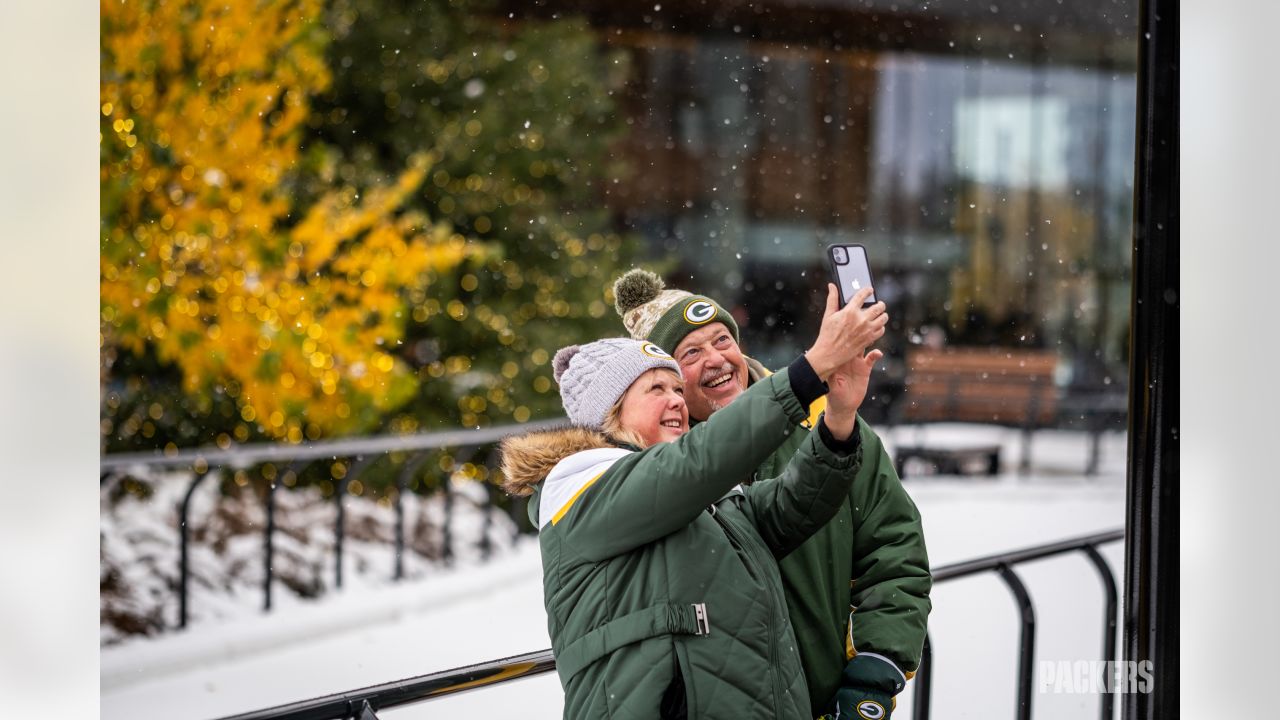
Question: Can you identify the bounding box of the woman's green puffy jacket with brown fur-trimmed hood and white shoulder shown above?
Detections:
[503,372,859,720]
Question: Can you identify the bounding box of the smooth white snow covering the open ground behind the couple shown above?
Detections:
[101,425,1125,720]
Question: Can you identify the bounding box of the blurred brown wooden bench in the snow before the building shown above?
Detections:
[893,347,1057,475]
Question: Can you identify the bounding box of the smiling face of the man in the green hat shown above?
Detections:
[672,323,746,420]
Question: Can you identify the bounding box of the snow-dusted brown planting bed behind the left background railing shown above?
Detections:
[99,469,517,646]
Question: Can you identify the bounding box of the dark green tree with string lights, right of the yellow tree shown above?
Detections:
[312,0,632,430]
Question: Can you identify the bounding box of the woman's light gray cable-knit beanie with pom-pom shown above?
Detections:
[552,337,684,429]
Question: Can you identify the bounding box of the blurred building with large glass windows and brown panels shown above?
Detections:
[504,0,1138,412]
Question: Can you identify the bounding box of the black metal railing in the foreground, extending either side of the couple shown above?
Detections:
[207,530,1124,720]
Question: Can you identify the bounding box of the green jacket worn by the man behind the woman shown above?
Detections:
[742,360,933,716]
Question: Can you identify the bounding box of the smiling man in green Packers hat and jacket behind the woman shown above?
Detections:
[613,269,932,720]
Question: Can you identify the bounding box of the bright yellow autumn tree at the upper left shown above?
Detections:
[100,0,488,447]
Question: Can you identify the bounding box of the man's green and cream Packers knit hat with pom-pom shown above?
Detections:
[613,268,739,352]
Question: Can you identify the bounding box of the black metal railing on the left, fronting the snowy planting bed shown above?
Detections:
[100,419,566,628]
